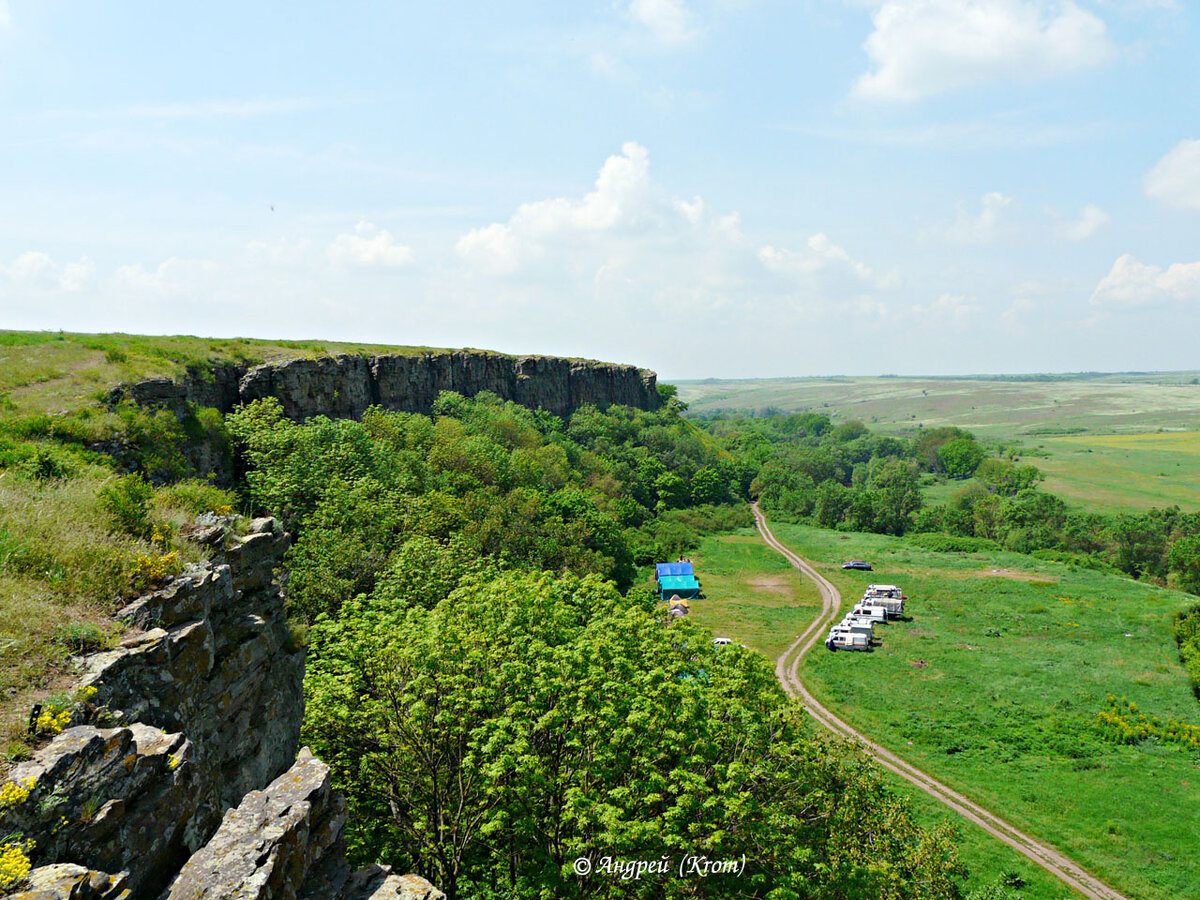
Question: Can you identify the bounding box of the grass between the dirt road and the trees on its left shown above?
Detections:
[676,528,1070,900]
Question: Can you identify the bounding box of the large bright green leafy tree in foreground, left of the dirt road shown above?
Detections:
[304,572,961,900]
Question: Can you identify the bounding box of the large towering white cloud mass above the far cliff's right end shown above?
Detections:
[453,143,896,332]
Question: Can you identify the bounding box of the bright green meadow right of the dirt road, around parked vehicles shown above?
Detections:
[774,524,1200,900]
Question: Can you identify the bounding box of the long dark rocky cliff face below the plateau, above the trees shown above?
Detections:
[113,350,659,421]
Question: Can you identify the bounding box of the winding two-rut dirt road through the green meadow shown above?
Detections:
[754,504,1128,900]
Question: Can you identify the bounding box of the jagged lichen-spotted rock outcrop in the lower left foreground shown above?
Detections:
[0,518,440,900]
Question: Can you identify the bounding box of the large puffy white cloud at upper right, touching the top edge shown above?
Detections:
[854,0,1115,101]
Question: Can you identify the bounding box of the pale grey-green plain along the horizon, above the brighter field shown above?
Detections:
[676,372,1200,440]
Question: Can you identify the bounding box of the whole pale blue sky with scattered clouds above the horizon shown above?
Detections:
[0,0,1200,378]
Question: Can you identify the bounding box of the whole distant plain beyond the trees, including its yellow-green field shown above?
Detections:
[677,372,1200,512]
